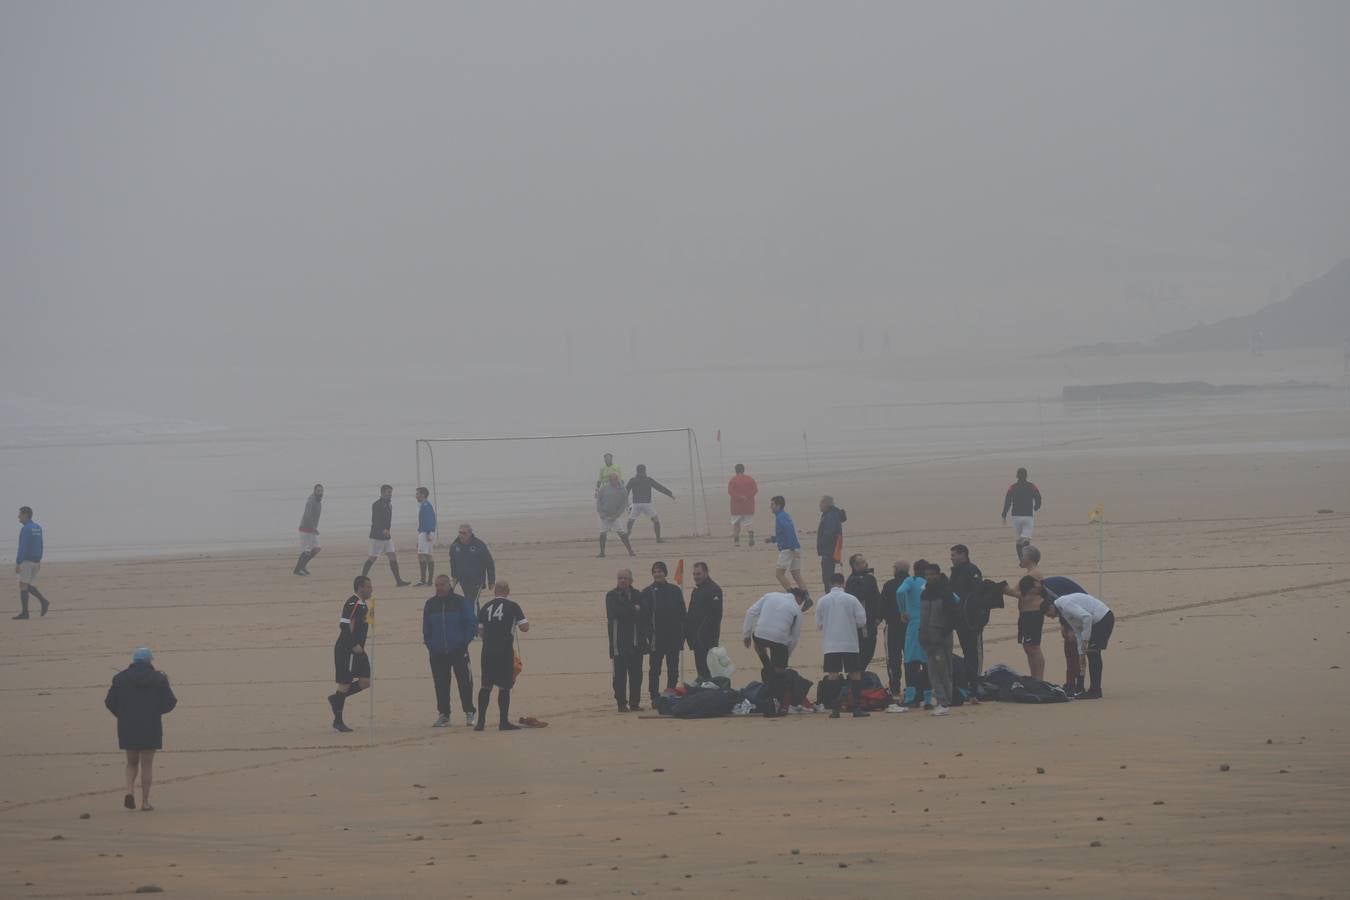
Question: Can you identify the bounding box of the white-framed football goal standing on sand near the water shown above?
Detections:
[416,428,711,541]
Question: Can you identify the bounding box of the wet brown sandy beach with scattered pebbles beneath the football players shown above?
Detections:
[0,417,1350,897]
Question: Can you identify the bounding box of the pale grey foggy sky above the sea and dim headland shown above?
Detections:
[0,0,1350,391]
